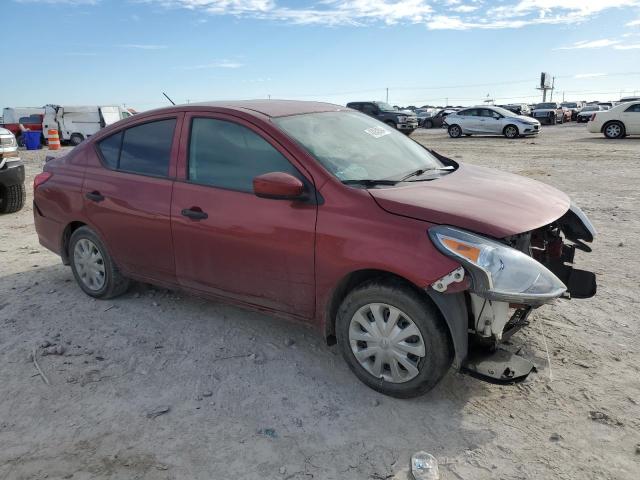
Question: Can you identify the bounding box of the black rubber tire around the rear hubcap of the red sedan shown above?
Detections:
[68,227,129,300]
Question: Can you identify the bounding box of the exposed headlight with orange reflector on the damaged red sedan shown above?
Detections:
[429,226,567,305]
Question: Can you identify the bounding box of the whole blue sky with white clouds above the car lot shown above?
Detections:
[0,0,640,110]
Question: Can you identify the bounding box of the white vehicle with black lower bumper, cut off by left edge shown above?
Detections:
[0,128,26,213]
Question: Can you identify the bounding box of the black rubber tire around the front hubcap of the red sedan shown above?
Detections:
[336,280,453,398]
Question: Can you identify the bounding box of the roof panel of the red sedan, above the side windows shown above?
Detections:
[138,99,349,117]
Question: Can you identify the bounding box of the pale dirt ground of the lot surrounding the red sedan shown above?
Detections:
[0,124,640,480]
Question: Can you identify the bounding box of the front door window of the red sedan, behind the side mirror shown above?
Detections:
[189,118,301,192]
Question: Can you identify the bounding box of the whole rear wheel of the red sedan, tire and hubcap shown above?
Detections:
[69,227,129,299]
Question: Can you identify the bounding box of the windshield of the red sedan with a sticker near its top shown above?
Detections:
[273,112,443,181]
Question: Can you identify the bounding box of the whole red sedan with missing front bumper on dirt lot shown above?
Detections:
[33,100,596,397]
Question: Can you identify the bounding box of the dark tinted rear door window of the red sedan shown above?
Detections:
[98,118,176,177]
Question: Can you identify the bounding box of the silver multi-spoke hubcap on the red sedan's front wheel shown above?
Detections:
[349,303,425,383]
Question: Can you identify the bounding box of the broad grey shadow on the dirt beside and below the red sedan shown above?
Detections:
[0,265,510,478]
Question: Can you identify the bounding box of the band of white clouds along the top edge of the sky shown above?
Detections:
[144,0,640,30]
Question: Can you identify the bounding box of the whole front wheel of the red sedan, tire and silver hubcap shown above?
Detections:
[336,281,452,398]
